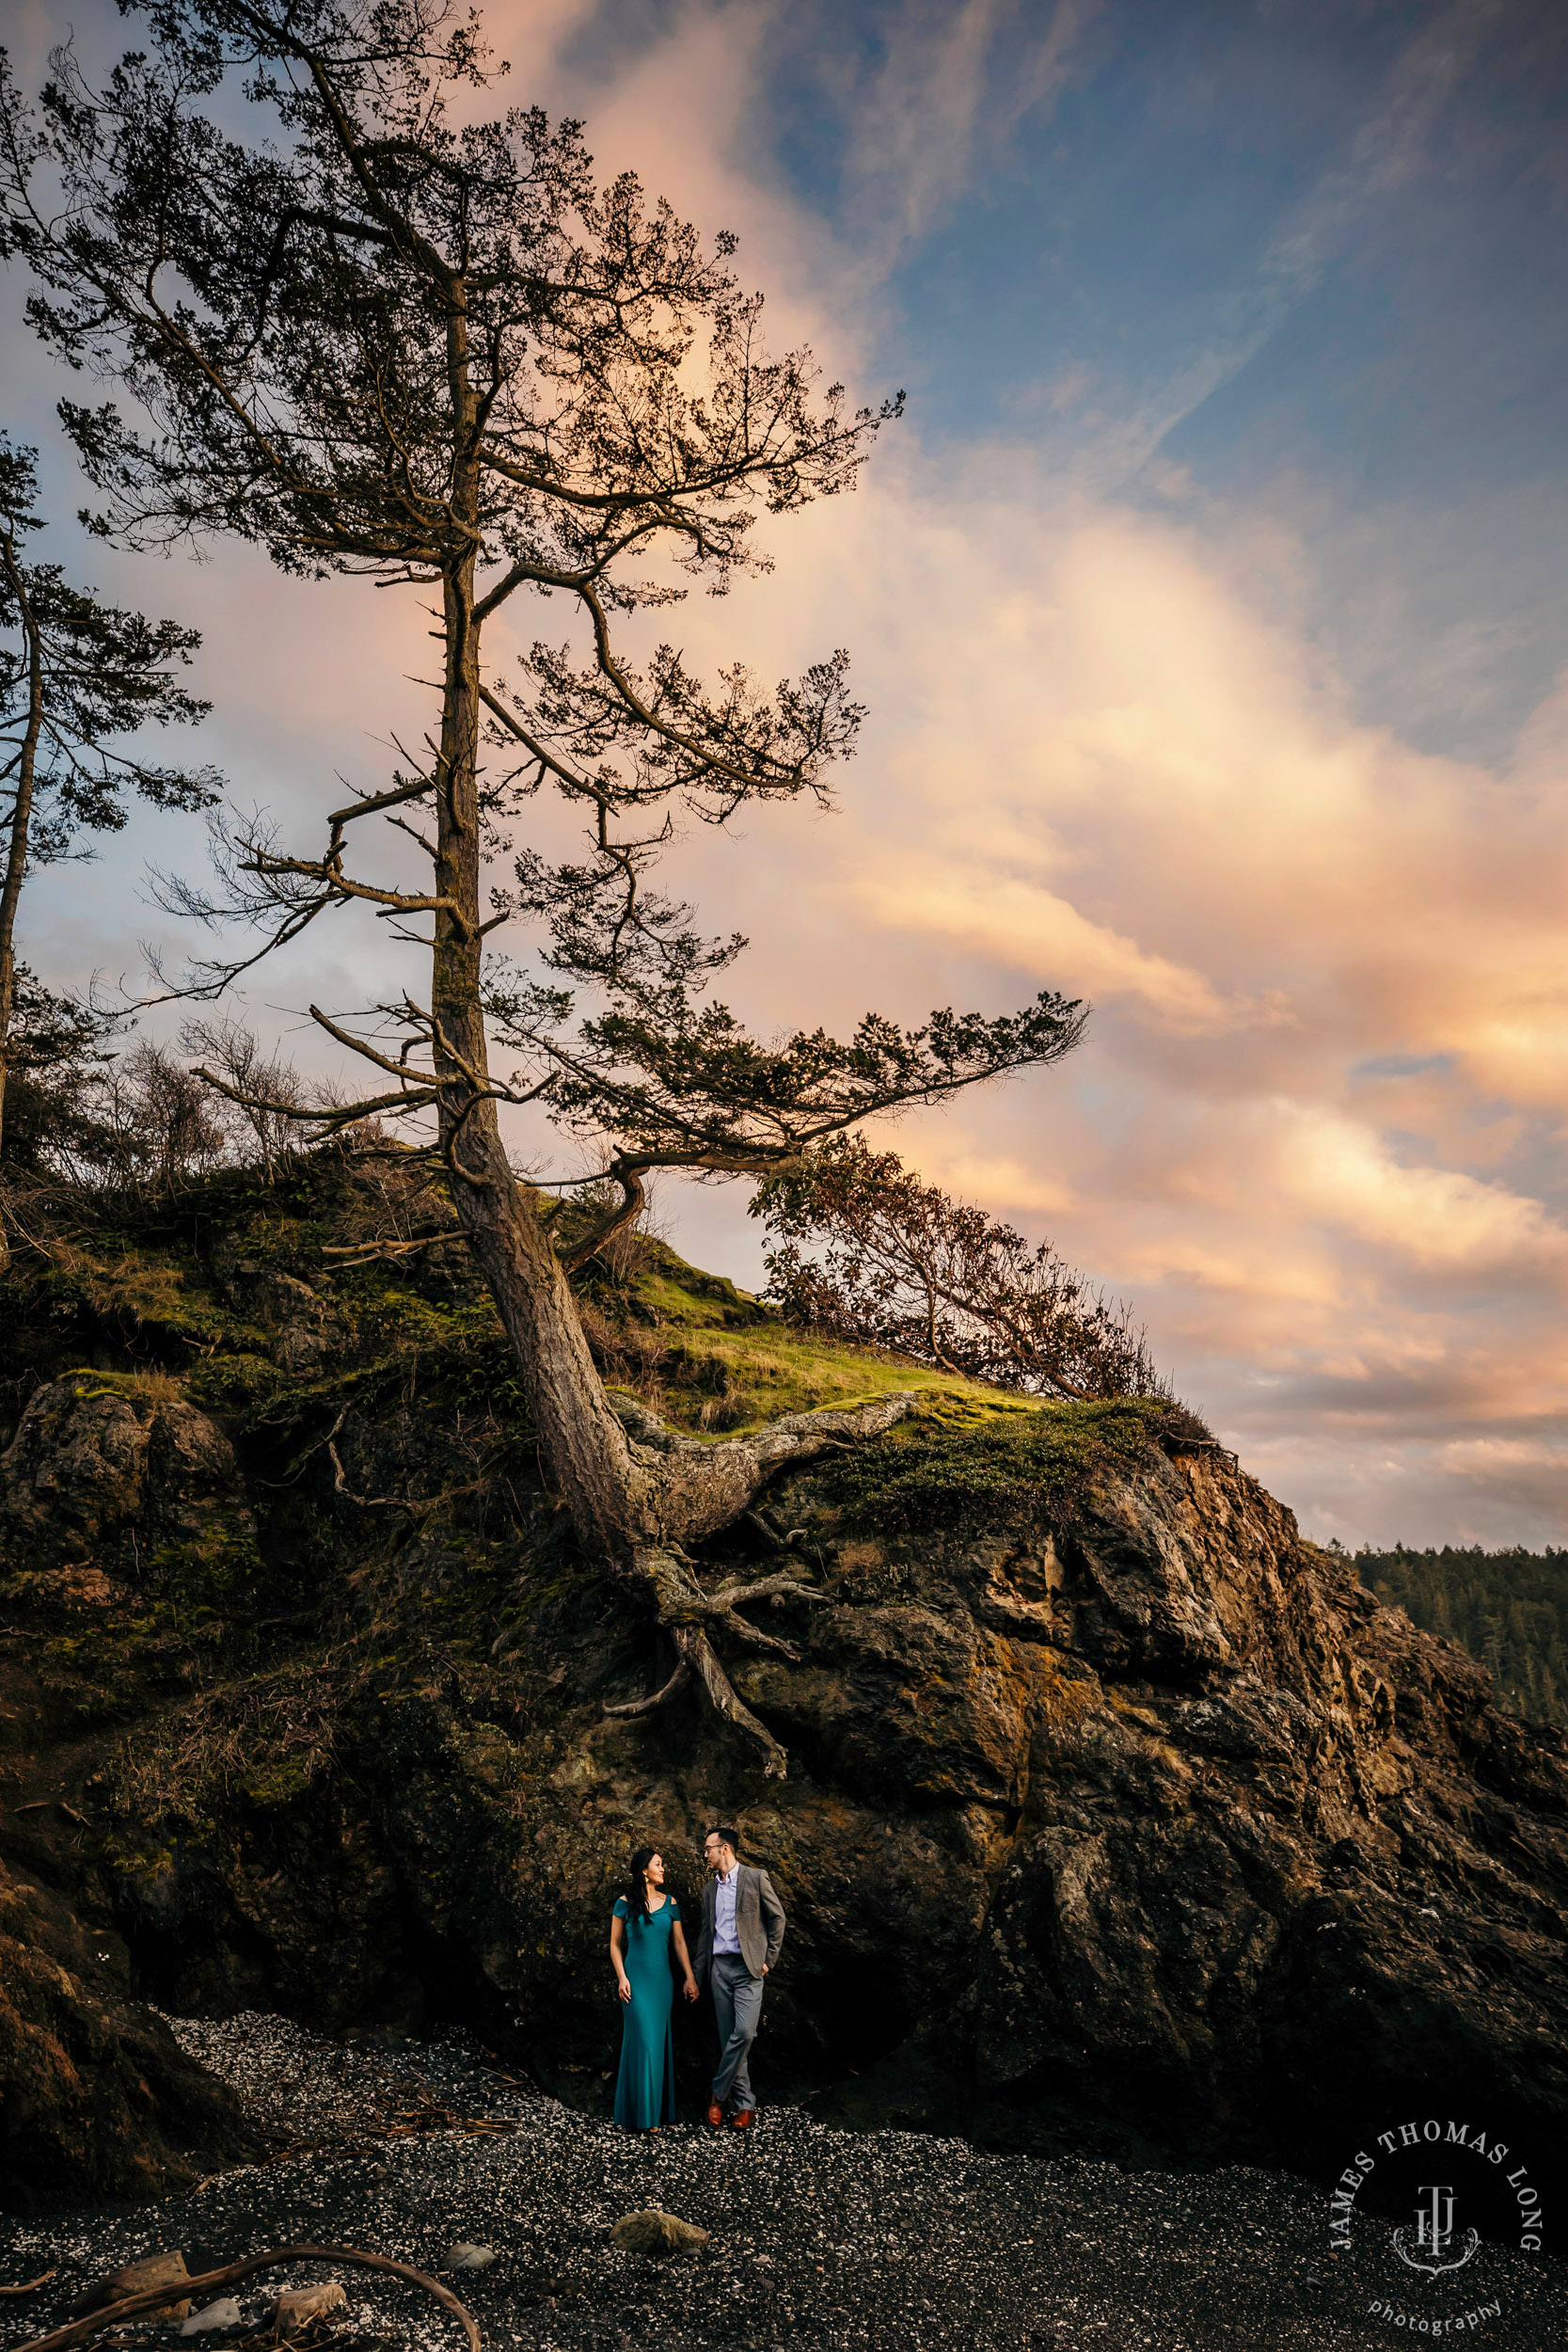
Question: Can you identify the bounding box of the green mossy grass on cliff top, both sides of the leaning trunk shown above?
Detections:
[5,1152,1162,1532]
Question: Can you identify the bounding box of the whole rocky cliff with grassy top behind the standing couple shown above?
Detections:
[0,1160,1568,2204]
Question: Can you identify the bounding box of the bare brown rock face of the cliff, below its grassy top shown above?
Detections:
[0,1223,1568,2195]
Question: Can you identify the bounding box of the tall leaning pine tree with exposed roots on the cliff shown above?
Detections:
[0,0,1082,1772]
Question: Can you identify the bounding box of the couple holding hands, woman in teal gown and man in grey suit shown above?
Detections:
[609,1828,785,2131]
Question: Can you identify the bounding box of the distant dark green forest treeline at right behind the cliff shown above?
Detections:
[1356,1543,1568,1724]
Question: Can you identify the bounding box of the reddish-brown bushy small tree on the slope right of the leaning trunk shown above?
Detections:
[752,1136,1171,1397]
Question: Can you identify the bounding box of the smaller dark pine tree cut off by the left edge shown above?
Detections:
[0,436,218,1265]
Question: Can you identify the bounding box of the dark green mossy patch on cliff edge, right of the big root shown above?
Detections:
[816,1392,1164,1536]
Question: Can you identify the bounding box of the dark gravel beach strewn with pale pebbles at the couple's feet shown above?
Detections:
[0,2016,1568,2352]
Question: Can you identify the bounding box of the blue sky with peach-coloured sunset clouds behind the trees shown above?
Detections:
[0,0,1568,1548]
